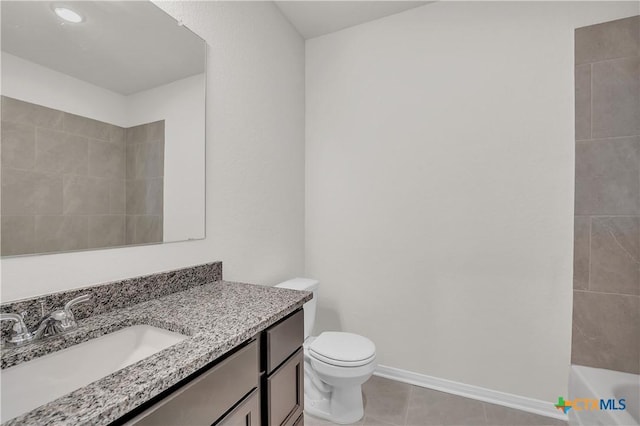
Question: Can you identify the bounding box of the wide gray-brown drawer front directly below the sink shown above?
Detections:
[126,340,259,426]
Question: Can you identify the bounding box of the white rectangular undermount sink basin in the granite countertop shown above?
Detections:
[0,325,187,423]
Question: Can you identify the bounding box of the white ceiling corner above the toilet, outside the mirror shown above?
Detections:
[275,0,431,39]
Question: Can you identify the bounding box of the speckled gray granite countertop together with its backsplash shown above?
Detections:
[1,262,312,426]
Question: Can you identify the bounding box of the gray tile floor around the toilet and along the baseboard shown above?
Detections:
[304,376,567,426]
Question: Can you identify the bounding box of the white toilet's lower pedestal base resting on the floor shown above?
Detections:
[304,386,364,425]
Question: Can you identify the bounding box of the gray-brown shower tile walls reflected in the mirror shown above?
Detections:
[1,96,164,256]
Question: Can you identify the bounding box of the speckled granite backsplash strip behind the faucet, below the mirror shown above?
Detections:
[0,262,222,338]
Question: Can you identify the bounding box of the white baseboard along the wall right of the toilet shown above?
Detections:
[373,365,567,421]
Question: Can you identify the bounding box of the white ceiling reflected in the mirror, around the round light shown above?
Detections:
[2,0,206,95]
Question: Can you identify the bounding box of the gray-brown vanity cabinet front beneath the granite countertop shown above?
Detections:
[114,309,304,426]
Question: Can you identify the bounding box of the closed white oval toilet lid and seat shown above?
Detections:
[309,331,376,367]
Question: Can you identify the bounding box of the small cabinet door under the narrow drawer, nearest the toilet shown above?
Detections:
[267,348,304,426]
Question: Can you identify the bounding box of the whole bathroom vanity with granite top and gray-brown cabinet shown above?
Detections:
[2,264,312,426]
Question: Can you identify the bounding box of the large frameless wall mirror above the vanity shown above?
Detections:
[0,1,206,256]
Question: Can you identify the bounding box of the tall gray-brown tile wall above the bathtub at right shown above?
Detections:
[571,16,640,373]
